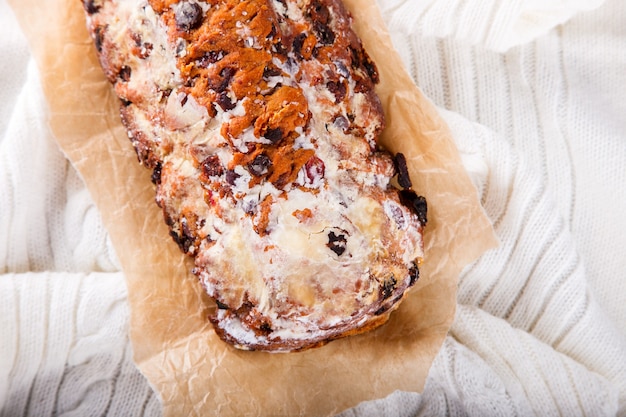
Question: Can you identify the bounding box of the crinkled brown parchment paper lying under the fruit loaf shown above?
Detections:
[9,0,496,416]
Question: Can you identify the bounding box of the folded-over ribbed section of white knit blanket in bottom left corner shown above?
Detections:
[0,272,160,417]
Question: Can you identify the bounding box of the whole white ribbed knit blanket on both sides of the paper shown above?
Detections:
[0,0,626,417]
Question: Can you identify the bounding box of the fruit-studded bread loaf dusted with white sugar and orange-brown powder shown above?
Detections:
[83,0,426,351]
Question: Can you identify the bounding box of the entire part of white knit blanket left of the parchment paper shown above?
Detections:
[0,1,161,417]
